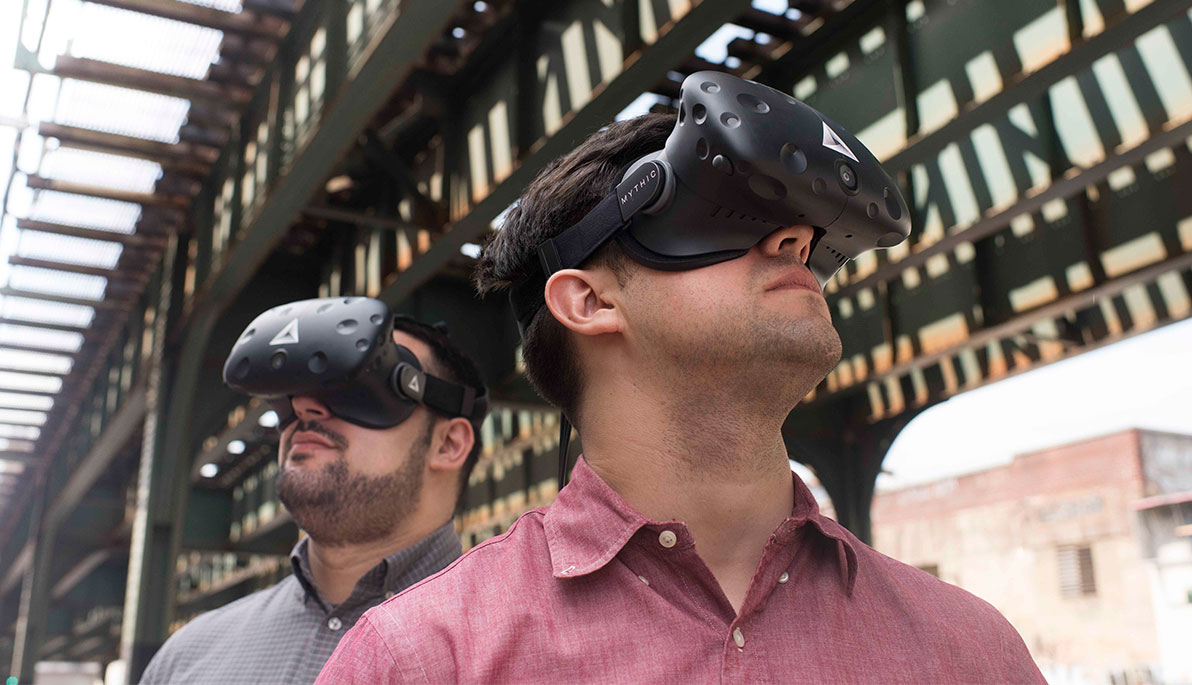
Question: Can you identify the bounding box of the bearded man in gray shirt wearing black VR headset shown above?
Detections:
[142,312,486,683]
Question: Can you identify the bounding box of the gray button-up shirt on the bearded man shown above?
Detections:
[141,523,460,683]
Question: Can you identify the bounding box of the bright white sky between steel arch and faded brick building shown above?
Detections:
[877,320,1192,490]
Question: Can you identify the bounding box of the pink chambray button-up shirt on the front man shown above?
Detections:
[318,459,1044,684]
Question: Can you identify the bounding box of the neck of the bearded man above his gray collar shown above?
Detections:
[306,522,443,604]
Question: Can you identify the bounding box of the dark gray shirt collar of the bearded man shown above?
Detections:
[290,521,461,603]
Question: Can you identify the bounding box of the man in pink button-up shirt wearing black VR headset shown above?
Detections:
[319,73,1043,684]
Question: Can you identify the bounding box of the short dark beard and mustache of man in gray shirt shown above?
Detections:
[278,417,434,547]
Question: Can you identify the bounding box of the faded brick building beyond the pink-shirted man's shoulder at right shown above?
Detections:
[873,430,1192,683]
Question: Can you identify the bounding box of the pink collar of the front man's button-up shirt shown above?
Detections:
[542,456,857,594]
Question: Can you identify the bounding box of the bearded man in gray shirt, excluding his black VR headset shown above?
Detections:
[141,317,484,683]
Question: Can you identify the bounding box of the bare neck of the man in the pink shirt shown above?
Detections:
[581,362,794,610]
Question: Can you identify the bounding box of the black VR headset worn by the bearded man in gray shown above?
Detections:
[223,298,489,429]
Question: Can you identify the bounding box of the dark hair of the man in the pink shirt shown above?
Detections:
[474,114,675,422]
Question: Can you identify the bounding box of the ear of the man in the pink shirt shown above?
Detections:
[544,269,623,336]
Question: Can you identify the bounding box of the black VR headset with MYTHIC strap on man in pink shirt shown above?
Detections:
[509,71,911,487]
